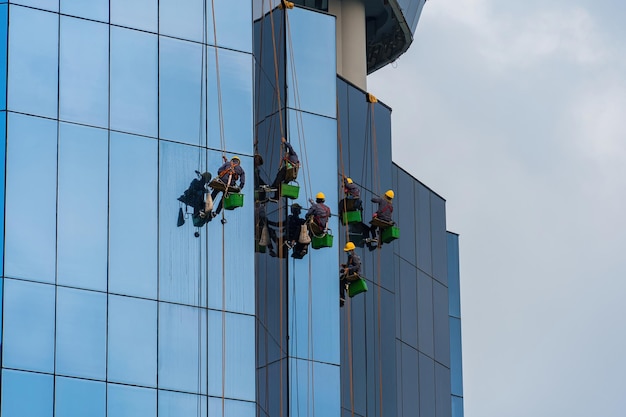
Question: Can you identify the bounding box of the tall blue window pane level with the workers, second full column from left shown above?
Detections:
[57,123,108,291]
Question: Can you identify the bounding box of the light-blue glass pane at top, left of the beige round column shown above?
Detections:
[286,8,337,117]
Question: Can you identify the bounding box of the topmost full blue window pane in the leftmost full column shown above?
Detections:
[8,6,59,118]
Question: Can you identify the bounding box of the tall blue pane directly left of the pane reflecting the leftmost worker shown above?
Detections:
[109,132,158,299]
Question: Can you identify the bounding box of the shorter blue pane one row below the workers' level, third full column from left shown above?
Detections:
[108,295,157,387]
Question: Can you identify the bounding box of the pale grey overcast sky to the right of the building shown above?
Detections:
[368,0,626,417]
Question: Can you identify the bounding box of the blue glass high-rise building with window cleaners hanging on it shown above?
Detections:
[0,0,463,417]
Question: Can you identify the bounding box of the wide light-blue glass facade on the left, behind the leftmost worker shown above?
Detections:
[0,0,256,417]
